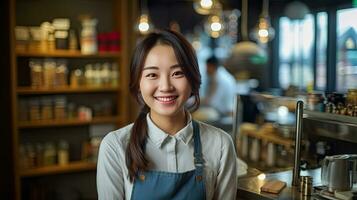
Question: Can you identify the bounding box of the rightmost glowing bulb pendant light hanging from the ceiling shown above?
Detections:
[251,0,275,44]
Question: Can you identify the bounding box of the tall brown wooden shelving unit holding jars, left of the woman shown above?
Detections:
[9,0,137,200]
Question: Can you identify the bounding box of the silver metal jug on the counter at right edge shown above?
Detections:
[321,154,357,192]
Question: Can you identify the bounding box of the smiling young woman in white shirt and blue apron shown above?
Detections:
[97,30,237,200]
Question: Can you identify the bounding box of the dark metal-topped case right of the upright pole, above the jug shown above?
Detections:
[303,109,357,168]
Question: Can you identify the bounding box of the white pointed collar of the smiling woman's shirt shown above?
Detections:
[146,112,193,148]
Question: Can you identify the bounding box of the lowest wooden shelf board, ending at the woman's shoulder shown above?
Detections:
[20,161,97,178]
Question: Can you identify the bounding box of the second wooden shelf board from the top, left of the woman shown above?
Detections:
[16,86,119,95]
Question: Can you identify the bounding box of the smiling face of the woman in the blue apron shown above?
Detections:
[140,45,192,118]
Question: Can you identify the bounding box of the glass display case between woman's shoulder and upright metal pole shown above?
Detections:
[233,93,305,172]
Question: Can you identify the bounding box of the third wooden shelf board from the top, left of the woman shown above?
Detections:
[18,116,120,128]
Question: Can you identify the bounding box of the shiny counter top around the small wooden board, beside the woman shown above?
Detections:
[237,168,321,200]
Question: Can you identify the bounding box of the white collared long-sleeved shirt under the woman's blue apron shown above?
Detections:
[97,115,237,200]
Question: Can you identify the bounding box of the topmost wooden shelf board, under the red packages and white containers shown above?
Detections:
[16,50,121,58]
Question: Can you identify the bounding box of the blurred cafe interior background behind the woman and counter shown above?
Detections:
[0,0,357,199]
